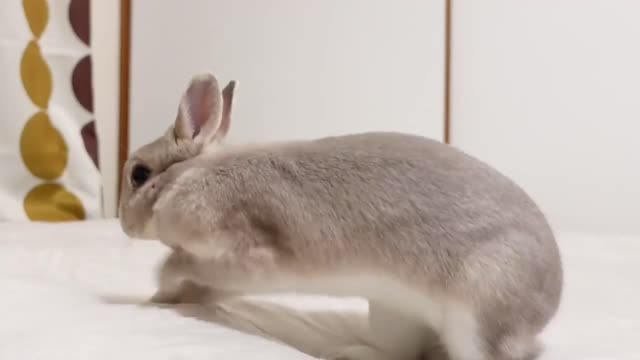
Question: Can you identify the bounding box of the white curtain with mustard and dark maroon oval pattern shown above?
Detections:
[0,0,102,221]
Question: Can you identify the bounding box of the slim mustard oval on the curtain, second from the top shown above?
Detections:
[20,40,53,110]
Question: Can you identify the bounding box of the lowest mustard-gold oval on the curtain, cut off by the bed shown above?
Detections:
[23,183,85,222]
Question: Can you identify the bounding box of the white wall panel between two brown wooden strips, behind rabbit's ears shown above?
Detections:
[130,0,444,149]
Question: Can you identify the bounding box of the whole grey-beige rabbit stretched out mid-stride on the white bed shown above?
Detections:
[119,72,563,360]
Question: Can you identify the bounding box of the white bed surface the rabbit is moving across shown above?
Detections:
[0,220,640,360]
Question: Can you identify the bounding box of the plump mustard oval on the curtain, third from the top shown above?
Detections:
[20,112,69,180]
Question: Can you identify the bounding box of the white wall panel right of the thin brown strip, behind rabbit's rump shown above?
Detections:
[452,0,640,234]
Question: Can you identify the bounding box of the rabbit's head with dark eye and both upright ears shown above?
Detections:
[119,73,236,239]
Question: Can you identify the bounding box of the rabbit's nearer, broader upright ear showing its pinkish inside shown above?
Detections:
[174,73,228,144]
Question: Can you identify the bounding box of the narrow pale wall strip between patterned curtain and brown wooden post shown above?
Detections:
[91,0,120,217]
